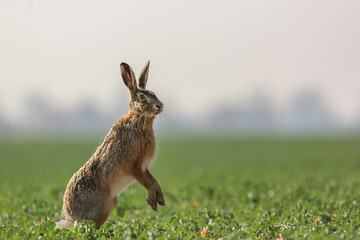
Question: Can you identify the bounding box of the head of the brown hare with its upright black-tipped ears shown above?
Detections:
[120,61,164,117]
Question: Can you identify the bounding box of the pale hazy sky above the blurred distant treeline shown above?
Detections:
[0,0,360,125]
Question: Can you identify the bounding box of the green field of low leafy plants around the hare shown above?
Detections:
[0,138,360,239]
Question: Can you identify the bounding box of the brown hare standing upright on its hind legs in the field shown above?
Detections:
[56,61,165,229]
